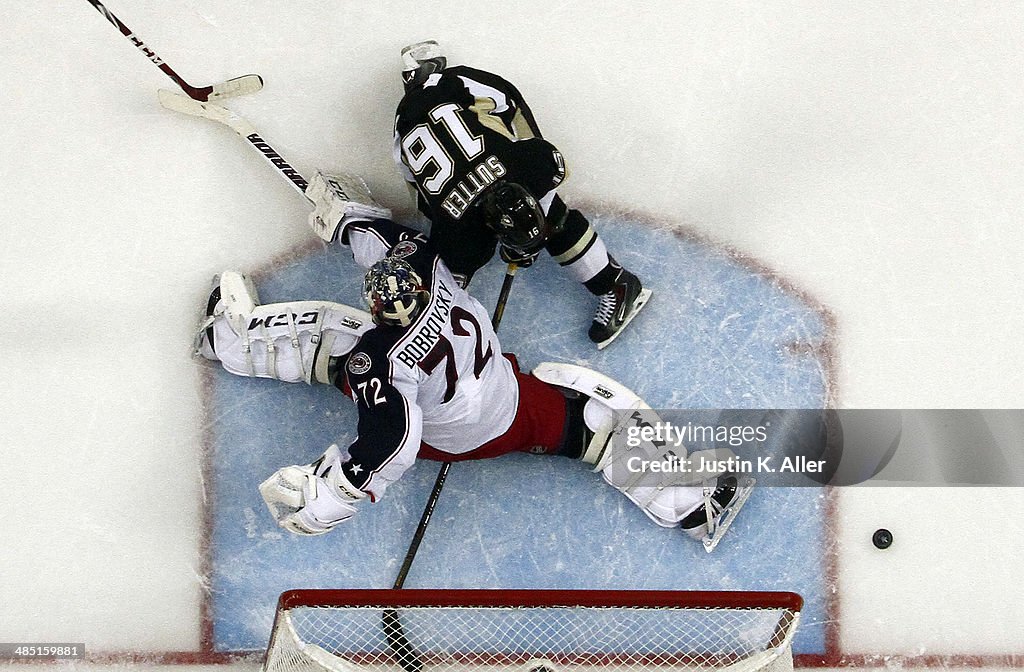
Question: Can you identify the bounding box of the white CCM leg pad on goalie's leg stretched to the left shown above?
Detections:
[203,301,374,384]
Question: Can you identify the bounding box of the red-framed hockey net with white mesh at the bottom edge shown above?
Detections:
[264,590,803,672]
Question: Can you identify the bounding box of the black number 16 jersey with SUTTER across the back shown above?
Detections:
[394,66,565,274]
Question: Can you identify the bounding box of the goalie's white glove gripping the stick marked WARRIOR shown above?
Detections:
[306,170,391,243]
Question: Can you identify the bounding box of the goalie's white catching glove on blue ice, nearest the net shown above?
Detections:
[259,444,367,536]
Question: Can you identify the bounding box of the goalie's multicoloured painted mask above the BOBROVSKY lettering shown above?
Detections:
[362,257,430,327]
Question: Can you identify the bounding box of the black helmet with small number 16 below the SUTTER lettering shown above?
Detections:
[481,180,548,253]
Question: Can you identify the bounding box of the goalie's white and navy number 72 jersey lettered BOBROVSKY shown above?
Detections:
[336,225,519,499]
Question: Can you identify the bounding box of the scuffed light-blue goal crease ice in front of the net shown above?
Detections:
[210,217,828,653]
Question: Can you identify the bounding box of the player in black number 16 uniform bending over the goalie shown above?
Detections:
[394,41,650,348]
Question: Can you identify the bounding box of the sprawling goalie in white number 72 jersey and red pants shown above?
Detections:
[196,174,752,550]
